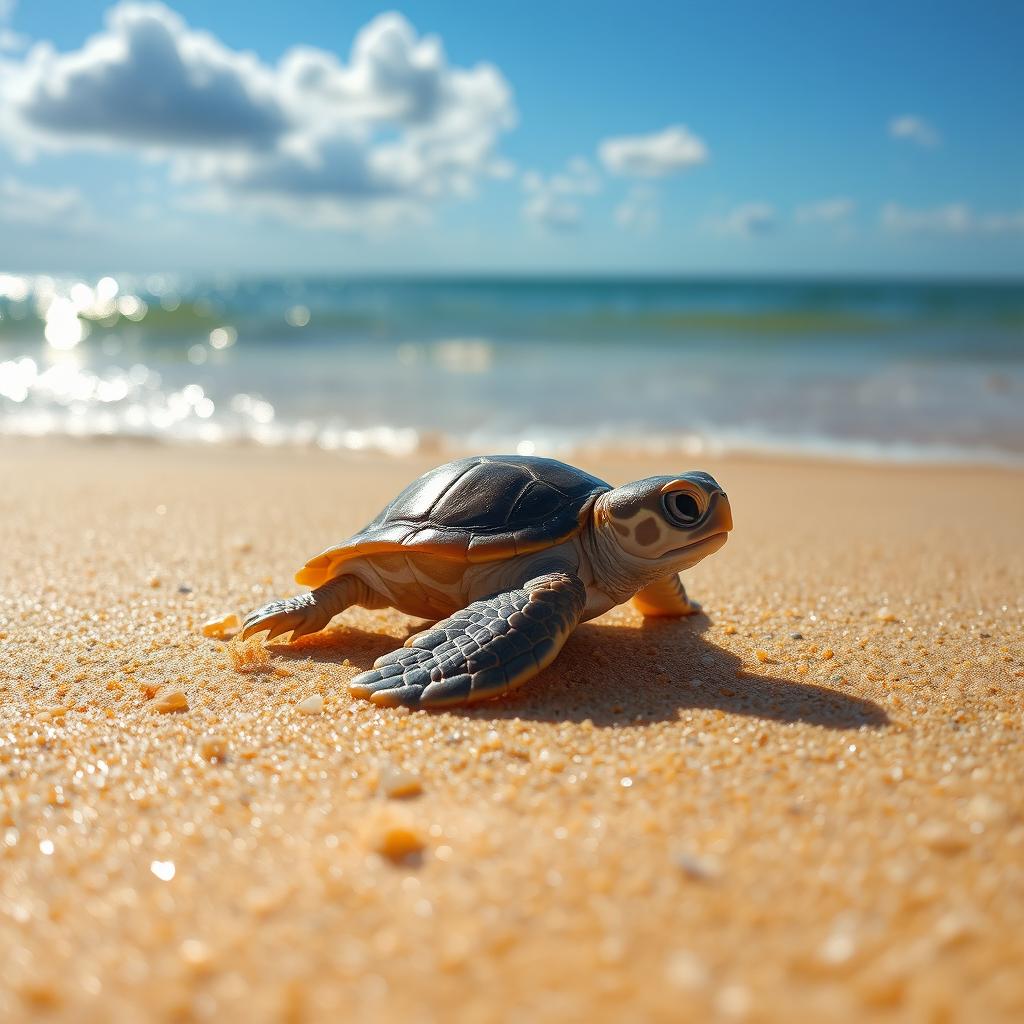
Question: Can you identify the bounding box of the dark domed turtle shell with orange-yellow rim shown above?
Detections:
[295,456,611,587]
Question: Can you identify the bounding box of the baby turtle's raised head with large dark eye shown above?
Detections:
[596,472,732,571]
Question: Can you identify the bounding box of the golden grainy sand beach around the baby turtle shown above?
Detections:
[0,441,1024,1022]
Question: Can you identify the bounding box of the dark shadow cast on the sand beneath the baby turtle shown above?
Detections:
[272,614,889,729]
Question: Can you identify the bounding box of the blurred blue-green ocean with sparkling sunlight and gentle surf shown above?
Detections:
[0,273,1024,463]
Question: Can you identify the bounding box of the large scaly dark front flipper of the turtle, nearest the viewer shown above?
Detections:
[349,572,587,708]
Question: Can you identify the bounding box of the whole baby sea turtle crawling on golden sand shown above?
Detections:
[242,456,732,708]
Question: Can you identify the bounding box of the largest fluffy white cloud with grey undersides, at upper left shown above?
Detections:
[0,0,515,226]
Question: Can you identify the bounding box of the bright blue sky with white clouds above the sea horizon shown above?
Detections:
[0,0,1024,275]
